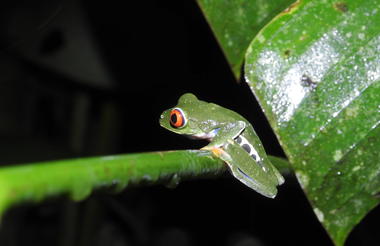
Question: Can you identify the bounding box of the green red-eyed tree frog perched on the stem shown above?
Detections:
[160,93,284,198]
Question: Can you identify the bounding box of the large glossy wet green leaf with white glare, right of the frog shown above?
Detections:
[245,0,380,245]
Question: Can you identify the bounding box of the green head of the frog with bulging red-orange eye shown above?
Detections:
[160,93,205,137]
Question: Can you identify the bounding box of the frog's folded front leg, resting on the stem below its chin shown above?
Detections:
[202,121,246,150]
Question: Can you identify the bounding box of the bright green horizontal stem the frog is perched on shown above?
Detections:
[0,150,288,219]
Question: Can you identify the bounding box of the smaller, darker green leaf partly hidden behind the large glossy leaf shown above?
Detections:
[198,0,294,78]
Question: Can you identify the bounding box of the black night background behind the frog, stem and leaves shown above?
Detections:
[0,0,379,246]
